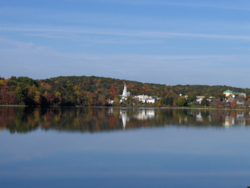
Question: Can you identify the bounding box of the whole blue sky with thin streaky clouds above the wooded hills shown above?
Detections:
[0,0,250,88]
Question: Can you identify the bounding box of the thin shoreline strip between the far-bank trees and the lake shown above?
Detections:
[0,104,250,111]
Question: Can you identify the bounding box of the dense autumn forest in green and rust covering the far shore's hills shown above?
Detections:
[0,76,250,106]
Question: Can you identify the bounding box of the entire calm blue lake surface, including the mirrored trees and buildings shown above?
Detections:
[0,107,250,188]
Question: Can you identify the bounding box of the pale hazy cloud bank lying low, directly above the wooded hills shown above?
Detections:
[0,38,250,87]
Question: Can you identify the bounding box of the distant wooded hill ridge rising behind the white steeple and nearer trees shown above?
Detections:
[40,76,250,97]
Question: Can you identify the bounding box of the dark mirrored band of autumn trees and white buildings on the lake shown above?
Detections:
[0,107,250,133]
